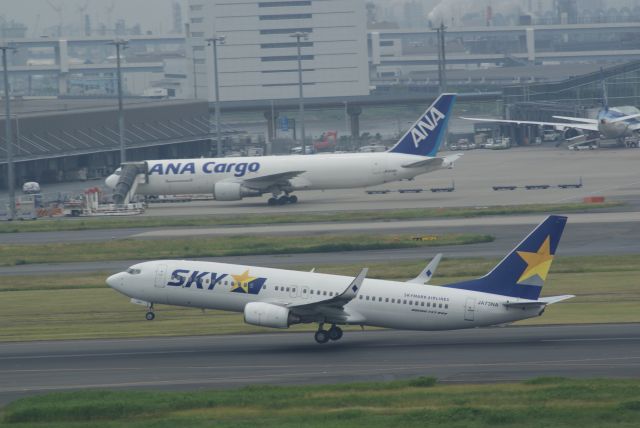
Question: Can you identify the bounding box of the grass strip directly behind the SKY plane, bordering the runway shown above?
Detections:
[0,255,640,342]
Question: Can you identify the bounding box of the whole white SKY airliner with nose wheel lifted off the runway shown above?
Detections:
[107,215,574,343]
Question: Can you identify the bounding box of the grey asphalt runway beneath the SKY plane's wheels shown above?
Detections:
[0,324,640,404]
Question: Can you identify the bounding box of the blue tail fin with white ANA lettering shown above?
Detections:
[389,94,456,157]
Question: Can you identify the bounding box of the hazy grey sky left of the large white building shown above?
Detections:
[0,0,182,36]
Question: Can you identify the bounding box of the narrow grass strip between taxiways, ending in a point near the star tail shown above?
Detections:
[0,234,493,266]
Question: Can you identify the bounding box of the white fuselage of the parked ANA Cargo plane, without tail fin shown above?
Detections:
[127,152,442,195]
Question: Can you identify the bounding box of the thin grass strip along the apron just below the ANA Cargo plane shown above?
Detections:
[0,202,623,233]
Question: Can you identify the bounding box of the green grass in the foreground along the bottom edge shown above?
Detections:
[0,378,640,428]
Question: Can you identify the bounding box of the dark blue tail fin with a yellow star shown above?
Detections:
[445,215,567,300]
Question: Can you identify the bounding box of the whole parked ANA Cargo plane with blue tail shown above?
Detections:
[106,94,461,205]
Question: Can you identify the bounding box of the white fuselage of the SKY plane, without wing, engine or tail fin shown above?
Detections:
[108,260,541,330]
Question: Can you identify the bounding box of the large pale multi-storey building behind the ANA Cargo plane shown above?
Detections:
[187,0,369,101]
